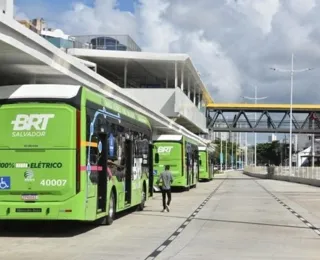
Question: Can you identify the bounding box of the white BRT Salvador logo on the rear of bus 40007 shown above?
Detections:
[11,114,55,137]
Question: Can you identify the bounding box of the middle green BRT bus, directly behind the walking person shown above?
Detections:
[153,135,199,190]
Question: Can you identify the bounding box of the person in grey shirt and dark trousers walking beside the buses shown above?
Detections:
[157,165,173,212]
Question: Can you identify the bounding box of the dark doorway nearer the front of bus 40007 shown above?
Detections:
[125,139,133,204]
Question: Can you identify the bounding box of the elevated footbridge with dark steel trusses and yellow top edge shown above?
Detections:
[206,103,320,134]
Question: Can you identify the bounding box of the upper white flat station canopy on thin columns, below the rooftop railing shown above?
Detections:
[67,36,213,104]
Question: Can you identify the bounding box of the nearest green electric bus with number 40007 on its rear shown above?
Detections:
[0,85,153,225]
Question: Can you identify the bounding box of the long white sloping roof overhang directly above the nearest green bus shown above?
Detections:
[0,13,209,146]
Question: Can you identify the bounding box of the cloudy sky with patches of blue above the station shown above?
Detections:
[15,0,320,144]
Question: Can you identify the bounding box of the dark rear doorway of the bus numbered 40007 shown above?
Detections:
[97,133,108,212]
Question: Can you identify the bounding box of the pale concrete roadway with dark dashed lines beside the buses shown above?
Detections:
[0,172,320,260]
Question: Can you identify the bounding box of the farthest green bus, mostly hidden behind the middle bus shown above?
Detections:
[199,146,214,181]
